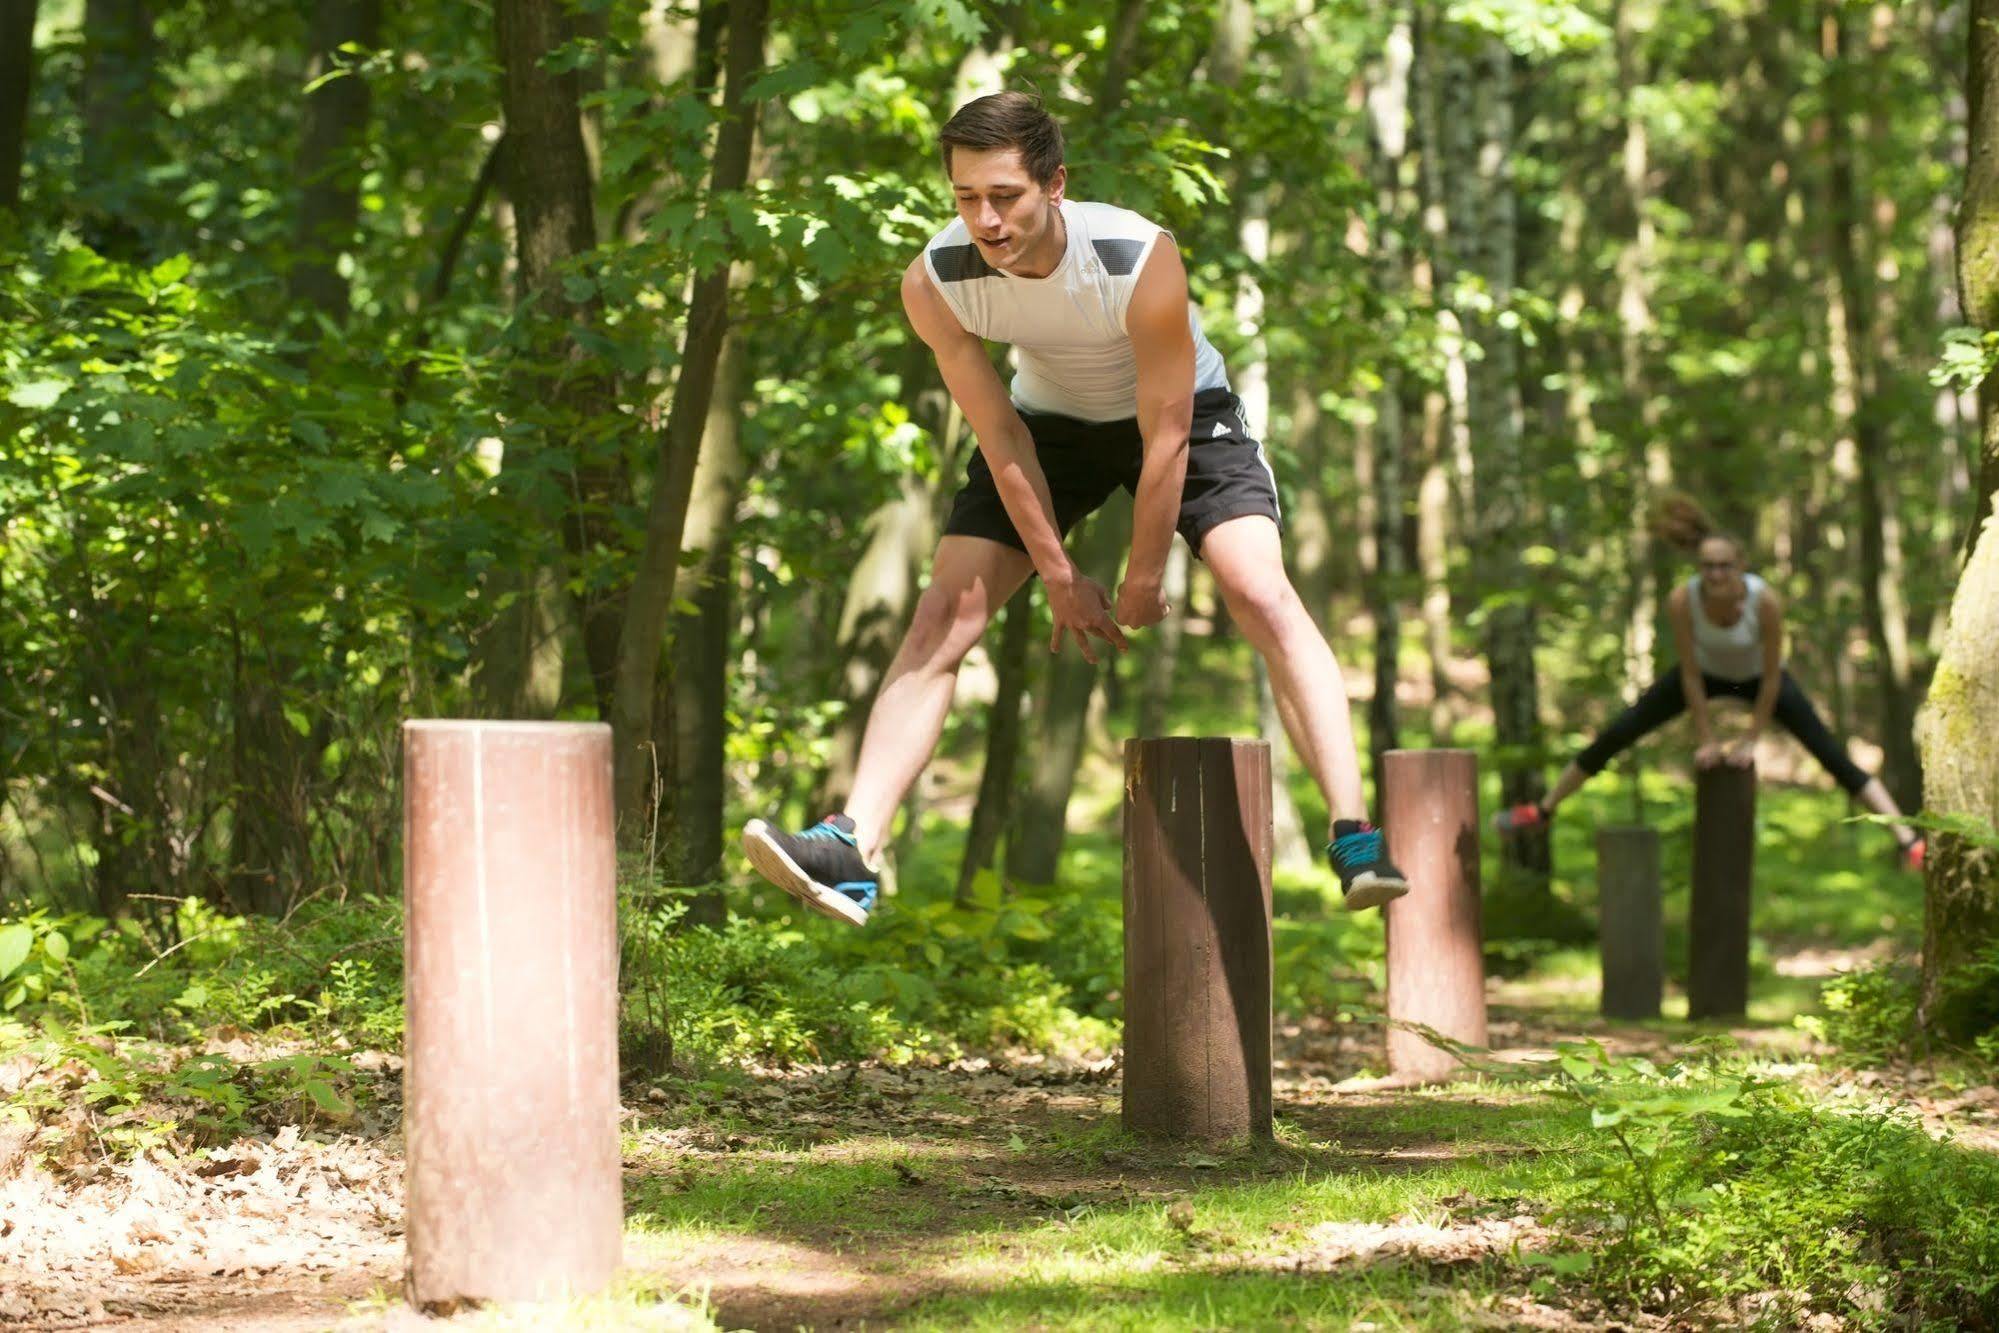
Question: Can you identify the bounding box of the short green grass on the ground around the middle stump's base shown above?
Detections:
[628,1087,1583,1329]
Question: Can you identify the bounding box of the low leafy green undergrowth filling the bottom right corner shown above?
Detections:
[1551,1043,1999,1327]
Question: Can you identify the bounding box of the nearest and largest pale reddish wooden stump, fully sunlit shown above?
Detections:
[402,721,624,1309]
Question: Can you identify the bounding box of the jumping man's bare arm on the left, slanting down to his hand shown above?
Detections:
[902,256,1125,662]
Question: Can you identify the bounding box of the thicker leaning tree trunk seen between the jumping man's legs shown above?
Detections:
[1005,492,1157,883]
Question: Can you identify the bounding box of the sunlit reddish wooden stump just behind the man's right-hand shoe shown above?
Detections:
[1381,749,1485,1083]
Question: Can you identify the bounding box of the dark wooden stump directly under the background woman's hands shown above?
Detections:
[1687,763,1755,1019]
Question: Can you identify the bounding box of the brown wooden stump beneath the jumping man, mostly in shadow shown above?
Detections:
[1123,737,1271,1141]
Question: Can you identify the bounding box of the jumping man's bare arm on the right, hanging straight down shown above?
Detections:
[1117,234,1193,626]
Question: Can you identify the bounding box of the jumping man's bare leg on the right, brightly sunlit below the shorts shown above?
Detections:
[1201,514,1367,837]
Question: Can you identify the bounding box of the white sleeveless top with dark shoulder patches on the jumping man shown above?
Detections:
[924,200,1229,422]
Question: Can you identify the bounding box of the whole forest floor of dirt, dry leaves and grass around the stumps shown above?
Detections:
[0,949,1999,1329]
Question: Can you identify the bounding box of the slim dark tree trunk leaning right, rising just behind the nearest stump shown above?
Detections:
[612,0,770,837]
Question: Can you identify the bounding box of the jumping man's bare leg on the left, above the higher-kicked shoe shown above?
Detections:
[846,536,1033,863]
